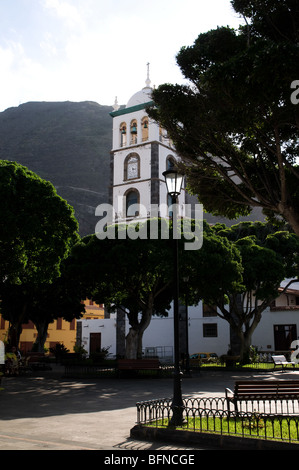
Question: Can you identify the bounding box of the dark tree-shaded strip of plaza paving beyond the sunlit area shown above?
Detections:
[0,371,295,420]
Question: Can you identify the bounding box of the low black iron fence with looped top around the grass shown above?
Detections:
[136,397,299,444]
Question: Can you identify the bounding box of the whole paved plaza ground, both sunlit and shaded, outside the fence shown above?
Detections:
[0,366,299,451]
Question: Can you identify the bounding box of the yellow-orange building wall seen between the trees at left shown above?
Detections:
[0,299,104,353]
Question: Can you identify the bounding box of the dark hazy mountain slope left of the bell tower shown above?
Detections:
[0,102,112,236]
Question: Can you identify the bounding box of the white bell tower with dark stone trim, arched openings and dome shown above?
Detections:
[110,64,185,222]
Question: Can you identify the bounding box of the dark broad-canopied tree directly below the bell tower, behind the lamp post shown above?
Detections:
[69,220,241,358]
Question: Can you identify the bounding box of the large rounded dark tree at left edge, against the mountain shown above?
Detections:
[0,160,79,342]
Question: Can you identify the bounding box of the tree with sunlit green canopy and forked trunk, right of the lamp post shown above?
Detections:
[192,222,299,362]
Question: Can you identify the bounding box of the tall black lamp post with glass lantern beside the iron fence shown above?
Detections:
[163,168,184,426]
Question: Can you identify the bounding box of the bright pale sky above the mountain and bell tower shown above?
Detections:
[0,0,242,111]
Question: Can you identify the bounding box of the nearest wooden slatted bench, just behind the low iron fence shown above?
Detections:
[225,380,299,412]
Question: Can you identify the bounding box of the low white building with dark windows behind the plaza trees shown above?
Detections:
[77,288,299,362]
